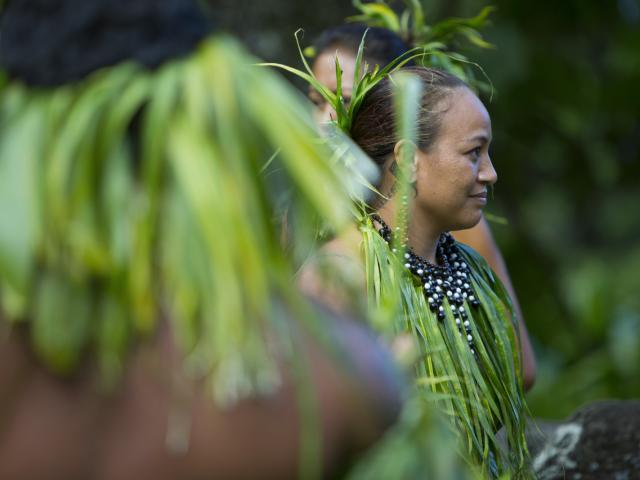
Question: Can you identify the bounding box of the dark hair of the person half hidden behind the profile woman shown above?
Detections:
[313,23,410,67]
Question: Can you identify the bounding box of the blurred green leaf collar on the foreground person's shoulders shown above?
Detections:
[0,38,360,402]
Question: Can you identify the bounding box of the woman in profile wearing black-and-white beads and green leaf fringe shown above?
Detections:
[302,67,527,478]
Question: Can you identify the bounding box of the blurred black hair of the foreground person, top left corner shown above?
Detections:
[0,0,212,86]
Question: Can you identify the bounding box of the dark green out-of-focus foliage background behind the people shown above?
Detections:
[212,0,640,418]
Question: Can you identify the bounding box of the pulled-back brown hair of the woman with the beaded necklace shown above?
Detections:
[351,67,468,168]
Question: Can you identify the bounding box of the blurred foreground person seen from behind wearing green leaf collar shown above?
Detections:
[0,0,402,479]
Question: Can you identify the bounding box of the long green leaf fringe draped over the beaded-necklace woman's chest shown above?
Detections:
[360,217,529,478]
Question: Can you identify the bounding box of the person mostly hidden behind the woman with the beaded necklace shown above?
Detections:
[309,24,536,390]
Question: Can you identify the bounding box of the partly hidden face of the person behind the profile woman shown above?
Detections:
[308,49,356,123]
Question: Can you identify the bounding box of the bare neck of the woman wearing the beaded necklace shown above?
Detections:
[377,197,442,264]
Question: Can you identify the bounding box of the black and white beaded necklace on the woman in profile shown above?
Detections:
[371,214,480,355]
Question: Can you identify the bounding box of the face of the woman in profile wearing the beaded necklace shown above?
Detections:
[414,88,498,231]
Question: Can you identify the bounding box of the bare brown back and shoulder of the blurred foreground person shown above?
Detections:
[0,308,402,480]
